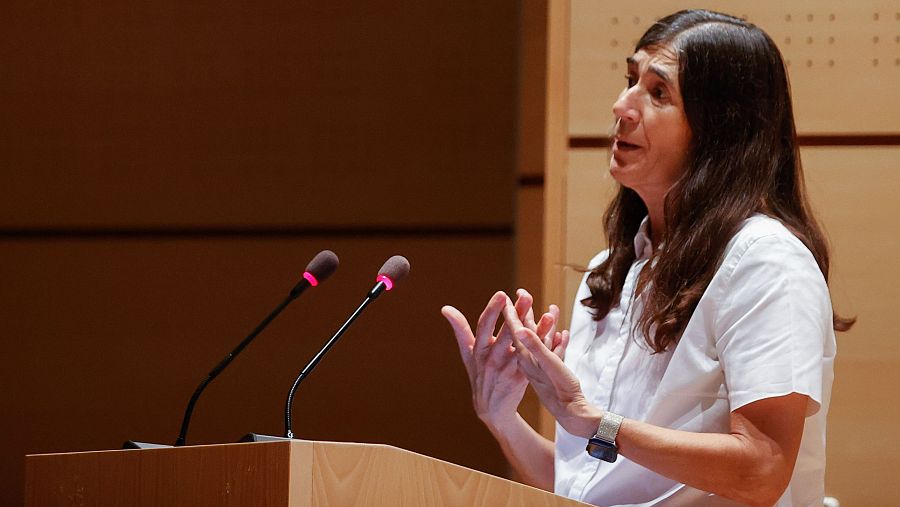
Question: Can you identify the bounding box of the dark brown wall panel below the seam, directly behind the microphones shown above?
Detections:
[0,236,513,505]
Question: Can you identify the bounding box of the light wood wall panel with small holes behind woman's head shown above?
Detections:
[569,0,900,136]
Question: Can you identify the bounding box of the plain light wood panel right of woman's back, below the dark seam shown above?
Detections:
[803,147,900,505]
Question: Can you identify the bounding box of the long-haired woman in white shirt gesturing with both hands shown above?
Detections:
[442,10,852,505]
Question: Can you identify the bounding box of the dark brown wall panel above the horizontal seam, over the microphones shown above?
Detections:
[0,1,517,228]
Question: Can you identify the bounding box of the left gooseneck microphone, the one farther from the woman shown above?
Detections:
[175,250,339,446]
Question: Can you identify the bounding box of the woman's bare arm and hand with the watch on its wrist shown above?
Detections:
[504,307,808,505]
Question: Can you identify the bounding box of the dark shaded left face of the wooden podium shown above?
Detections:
[25,442,291,507]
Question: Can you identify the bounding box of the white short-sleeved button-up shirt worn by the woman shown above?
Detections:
[555,215,835,506]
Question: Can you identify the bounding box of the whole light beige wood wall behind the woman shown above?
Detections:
[519,0,900,505]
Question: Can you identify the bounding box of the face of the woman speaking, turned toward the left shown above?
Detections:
[609,46,691,200]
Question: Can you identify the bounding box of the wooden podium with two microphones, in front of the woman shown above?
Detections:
[25,440,586,507]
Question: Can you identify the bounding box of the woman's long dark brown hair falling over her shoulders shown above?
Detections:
[582,10,854,352]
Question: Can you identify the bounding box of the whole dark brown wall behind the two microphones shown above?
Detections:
[0,2,518,505]
